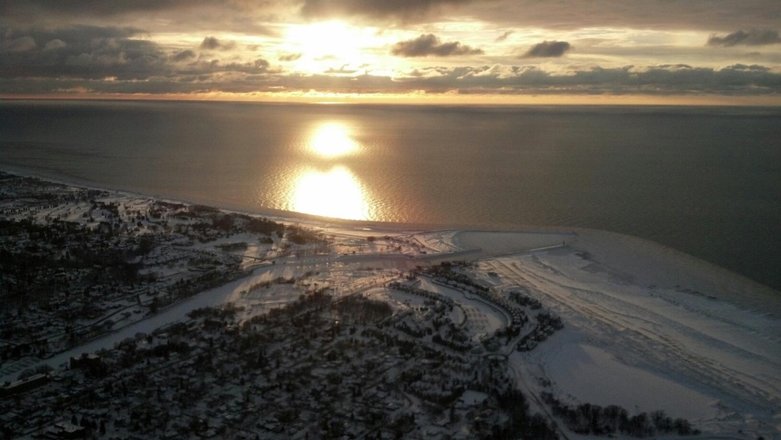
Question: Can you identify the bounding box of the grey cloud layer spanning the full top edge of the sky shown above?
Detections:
[0,0,779,34]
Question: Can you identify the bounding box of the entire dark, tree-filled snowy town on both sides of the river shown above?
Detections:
[0,174,708,439]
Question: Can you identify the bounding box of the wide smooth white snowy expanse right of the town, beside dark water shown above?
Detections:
[472,231,781,438]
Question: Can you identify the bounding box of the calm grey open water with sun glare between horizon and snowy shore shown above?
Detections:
[0,101,781,289]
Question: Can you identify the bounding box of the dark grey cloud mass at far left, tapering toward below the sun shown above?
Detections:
[0,26,271,85]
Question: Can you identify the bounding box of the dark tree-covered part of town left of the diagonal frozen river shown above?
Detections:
[0,175,326,368]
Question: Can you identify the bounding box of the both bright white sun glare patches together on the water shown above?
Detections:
[286,122,371,220]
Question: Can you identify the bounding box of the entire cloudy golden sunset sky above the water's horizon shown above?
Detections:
[0,0,781,105]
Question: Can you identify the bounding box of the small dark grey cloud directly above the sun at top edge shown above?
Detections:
[300,0,470,21]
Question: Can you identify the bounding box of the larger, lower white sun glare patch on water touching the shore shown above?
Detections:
[288,165,370,220]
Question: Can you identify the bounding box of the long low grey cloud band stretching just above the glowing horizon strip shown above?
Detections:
[0,57,781,96]
